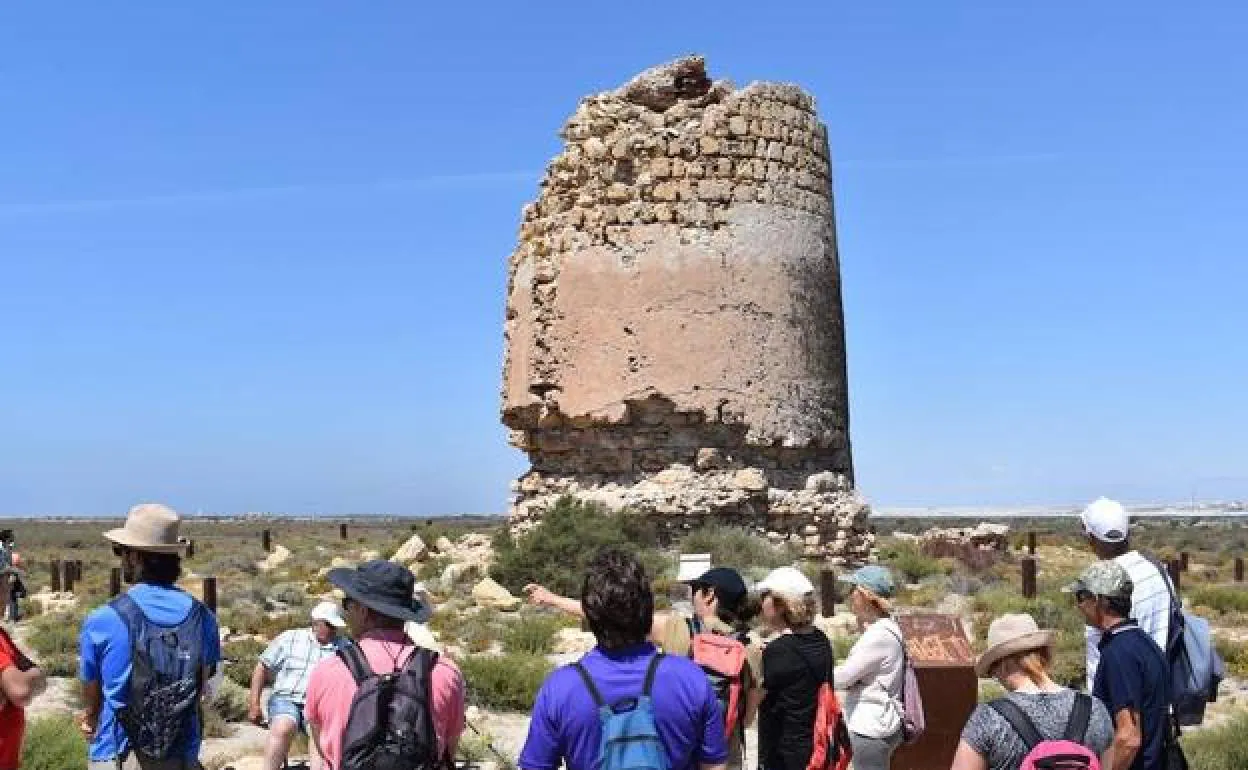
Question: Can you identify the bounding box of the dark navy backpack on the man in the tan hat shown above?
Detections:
[109,594,208,761]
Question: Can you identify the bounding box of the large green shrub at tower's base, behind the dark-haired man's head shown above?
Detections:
[489,497,665,595]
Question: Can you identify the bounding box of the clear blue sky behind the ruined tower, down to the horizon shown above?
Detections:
[0,0,1248,514]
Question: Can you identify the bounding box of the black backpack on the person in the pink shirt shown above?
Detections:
[338,636,451,770]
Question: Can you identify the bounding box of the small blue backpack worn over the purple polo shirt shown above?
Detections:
[573,653,671,770]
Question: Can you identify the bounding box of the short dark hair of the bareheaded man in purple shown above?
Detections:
[580,548,654,650]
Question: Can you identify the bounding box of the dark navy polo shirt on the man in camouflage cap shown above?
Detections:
[1092,620,1169,770]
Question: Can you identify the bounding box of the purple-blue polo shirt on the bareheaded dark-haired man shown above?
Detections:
[518,644,728,770]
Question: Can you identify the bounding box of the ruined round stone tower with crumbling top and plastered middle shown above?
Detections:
[503,57,872,562]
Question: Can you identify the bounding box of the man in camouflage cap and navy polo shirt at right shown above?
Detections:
[1066,560,1171,770]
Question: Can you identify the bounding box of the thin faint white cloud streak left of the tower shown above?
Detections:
[0,171,542,216]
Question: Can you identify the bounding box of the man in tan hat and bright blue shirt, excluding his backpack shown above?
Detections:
[79,504,221,770]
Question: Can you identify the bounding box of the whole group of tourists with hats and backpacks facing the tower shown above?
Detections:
[0,499,1208,770]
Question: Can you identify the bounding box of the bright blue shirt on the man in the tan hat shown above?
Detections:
[79,583,221,761]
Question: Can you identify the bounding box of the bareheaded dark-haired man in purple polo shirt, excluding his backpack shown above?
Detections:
[518,548,728,770]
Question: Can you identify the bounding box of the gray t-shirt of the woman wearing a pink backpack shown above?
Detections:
[962,690,1113,770]
